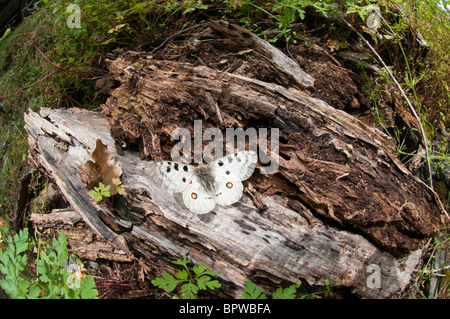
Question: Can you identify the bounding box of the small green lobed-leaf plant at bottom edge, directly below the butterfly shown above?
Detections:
[152,259,222,299]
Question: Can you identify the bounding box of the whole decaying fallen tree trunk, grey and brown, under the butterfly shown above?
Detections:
[25,21,441,298]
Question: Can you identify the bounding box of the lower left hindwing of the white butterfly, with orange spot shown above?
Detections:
[182,176,216,214]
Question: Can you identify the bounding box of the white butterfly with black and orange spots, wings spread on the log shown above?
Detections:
[149,151,258,214]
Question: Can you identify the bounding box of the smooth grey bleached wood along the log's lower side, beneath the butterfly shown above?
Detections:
[25,109,426,297]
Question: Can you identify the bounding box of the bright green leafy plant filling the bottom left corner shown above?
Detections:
[0,228,97,299]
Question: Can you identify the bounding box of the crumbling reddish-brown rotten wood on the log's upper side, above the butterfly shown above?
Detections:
[99,48,441,254]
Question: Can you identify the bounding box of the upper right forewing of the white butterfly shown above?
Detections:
[208,151,258,181]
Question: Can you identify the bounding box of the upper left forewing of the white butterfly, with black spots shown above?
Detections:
[149,161,194,193]
